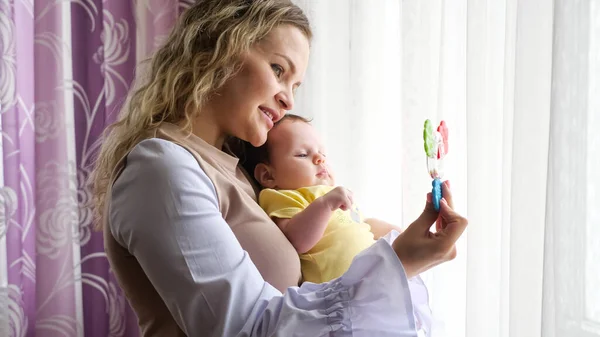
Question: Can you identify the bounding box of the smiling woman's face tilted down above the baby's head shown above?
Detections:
[209,25,309,146]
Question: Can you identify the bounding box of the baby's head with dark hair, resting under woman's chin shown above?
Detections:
[248,114,334,190]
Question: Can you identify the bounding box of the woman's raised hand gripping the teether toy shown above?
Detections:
[392,181,468,278]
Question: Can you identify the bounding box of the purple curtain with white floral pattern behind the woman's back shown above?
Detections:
[0,0,193,337]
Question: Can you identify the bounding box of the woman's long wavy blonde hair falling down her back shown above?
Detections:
[89,0,312,229]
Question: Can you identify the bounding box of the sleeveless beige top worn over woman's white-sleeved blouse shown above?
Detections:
[104,123,300,337]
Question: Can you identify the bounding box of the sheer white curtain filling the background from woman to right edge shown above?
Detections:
[295,0,600,337]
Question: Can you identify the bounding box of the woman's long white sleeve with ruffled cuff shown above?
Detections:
[109,139,432,337]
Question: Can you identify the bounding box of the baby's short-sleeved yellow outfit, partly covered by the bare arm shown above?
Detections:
[258,185,375,283]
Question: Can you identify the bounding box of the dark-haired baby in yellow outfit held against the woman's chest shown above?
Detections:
[248,114,399,283]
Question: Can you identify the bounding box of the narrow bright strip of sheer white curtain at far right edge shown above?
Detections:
[543,0,600,337]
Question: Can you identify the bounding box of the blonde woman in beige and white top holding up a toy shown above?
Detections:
[91,0,467,336]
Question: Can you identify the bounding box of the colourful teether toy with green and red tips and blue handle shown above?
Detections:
[423,119,448,211]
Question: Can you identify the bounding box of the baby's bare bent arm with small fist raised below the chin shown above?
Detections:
[274,187,352,254]
